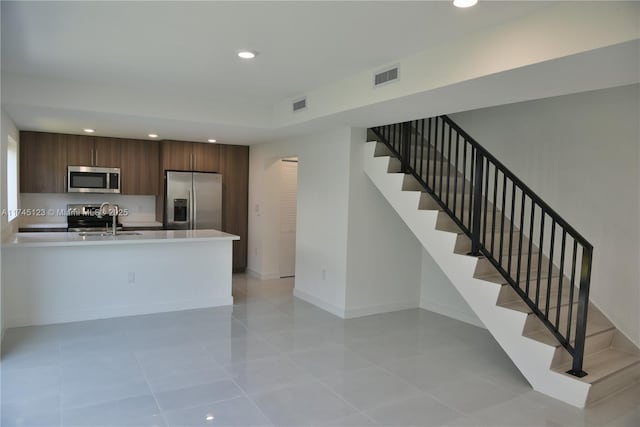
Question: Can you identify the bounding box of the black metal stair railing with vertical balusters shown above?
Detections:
[371,115,593,377]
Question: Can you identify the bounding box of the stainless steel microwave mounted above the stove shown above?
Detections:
[67,166,120,193]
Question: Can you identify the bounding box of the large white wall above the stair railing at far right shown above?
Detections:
[451,85,640,345]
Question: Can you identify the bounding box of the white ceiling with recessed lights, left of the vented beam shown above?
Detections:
[1,1,604,143]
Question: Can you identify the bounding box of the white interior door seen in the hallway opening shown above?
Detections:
[280,159,298,277]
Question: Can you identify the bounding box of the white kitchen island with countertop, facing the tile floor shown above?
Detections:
[2,230,240,327]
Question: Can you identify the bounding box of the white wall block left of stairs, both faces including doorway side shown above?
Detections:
[248,128,430,317]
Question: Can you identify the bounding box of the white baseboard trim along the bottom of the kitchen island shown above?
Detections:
[7,296,233,328]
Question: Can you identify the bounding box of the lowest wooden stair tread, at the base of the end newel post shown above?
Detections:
[553,347,640,384]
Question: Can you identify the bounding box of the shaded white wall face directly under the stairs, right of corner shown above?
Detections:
[345,129,422,317]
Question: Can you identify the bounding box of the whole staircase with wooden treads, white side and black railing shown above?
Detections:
[364,116,640,407]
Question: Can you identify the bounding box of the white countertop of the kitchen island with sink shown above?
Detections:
[2,230,240,249]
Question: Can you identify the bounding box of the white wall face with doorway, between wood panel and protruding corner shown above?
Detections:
[248,127,351,315]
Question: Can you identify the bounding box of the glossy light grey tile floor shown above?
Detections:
[0,275,640,427]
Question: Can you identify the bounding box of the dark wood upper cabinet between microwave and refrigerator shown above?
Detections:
[120,139,160,195]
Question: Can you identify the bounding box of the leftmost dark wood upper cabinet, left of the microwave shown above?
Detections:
[20,131,67,193]
